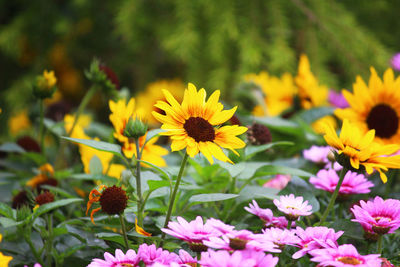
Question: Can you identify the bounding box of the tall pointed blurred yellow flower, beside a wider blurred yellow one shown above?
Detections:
[295,55,329,109]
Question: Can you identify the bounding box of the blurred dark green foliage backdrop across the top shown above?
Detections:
[0,0,400,136]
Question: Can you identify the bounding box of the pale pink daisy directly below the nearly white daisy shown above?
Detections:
[257,228,300,249]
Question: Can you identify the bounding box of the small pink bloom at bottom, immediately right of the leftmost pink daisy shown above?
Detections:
[138,243,179,265]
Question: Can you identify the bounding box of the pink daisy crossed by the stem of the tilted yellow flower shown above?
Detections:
[309,169,374,195]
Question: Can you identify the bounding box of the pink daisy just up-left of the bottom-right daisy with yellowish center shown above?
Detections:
[292,226,344,259]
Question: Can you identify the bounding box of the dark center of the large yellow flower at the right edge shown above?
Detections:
[367,104,399,138]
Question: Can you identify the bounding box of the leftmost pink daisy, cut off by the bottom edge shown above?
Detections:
[87,249,140,267]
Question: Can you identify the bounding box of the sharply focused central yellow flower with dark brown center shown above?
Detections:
[152,83,247,164]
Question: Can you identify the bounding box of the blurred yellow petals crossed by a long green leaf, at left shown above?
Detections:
[64,115,126,179]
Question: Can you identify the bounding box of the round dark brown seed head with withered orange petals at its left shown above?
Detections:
[100,185,128,215]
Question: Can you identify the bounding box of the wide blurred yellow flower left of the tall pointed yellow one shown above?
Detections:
[244,71,297,116]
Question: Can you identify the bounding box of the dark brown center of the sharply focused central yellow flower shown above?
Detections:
[183,117,215,142]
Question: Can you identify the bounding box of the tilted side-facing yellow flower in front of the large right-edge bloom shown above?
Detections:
[324,119,400,183]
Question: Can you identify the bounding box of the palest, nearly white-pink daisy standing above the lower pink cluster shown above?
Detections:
[274,194,312,221]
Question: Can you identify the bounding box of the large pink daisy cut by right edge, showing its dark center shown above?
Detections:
[351,196,400,234]
